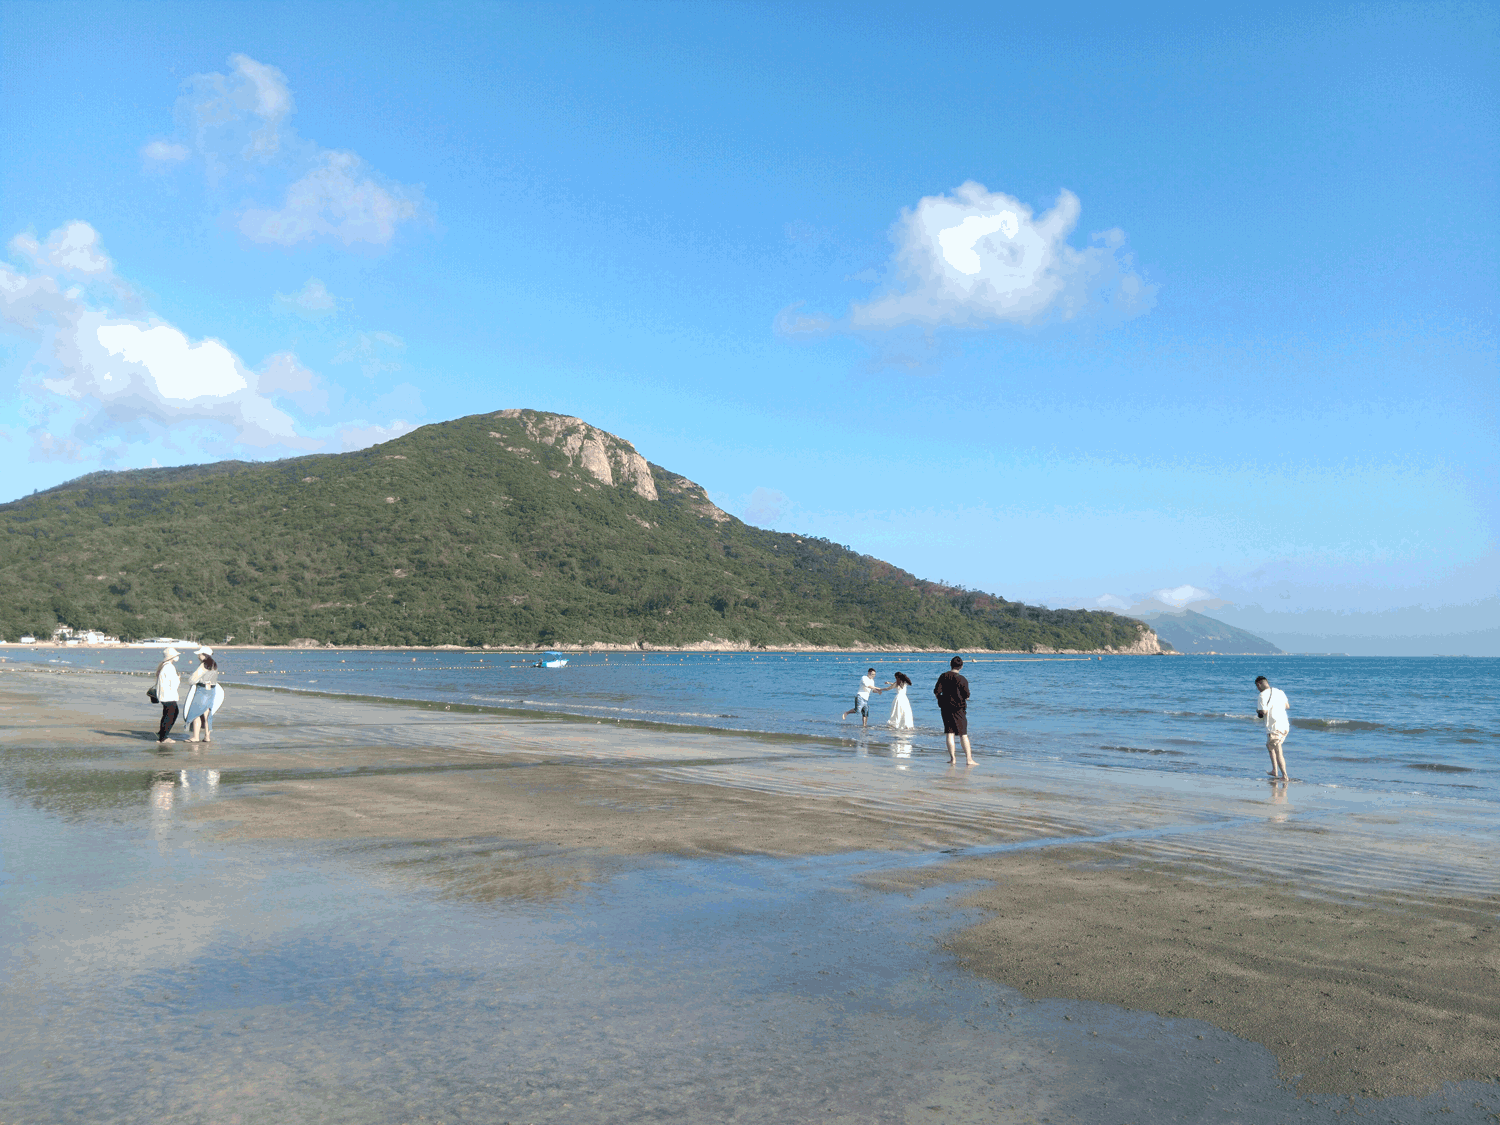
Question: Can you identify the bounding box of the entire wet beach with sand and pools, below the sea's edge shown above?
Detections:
[0,668,1500,1125]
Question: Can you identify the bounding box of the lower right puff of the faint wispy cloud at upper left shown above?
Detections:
[240,152,422,246]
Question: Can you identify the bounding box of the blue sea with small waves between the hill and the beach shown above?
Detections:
[0,647,1500,801]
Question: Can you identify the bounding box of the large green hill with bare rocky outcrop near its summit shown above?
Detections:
[0,410,1155,651]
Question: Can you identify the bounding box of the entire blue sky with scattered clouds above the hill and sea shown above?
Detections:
[0,3,1500,648]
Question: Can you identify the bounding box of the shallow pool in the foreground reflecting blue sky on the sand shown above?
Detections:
[0,771,1500,1124]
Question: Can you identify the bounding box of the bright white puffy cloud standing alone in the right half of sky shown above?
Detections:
[852,180,1155,330]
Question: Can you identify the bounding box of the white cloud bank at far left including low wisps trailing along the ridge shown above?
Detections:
[0,219,413,464]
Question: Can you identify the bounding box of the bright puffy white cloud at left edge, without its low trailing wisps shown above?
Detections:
[0,222,321,459]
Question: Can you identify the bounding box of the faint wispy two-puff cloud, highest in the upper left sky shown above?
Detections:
[156,54,425,246]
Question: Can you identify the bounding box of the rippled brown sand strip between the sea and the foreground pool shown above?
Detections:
[0,666,1500,1097]
